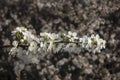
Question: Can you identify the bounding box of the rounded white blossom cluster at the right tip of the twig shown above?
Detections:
[79,35,106,53]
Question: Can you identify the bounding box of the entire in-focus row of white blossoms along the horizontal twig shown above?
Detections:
[10,27,106,55]
